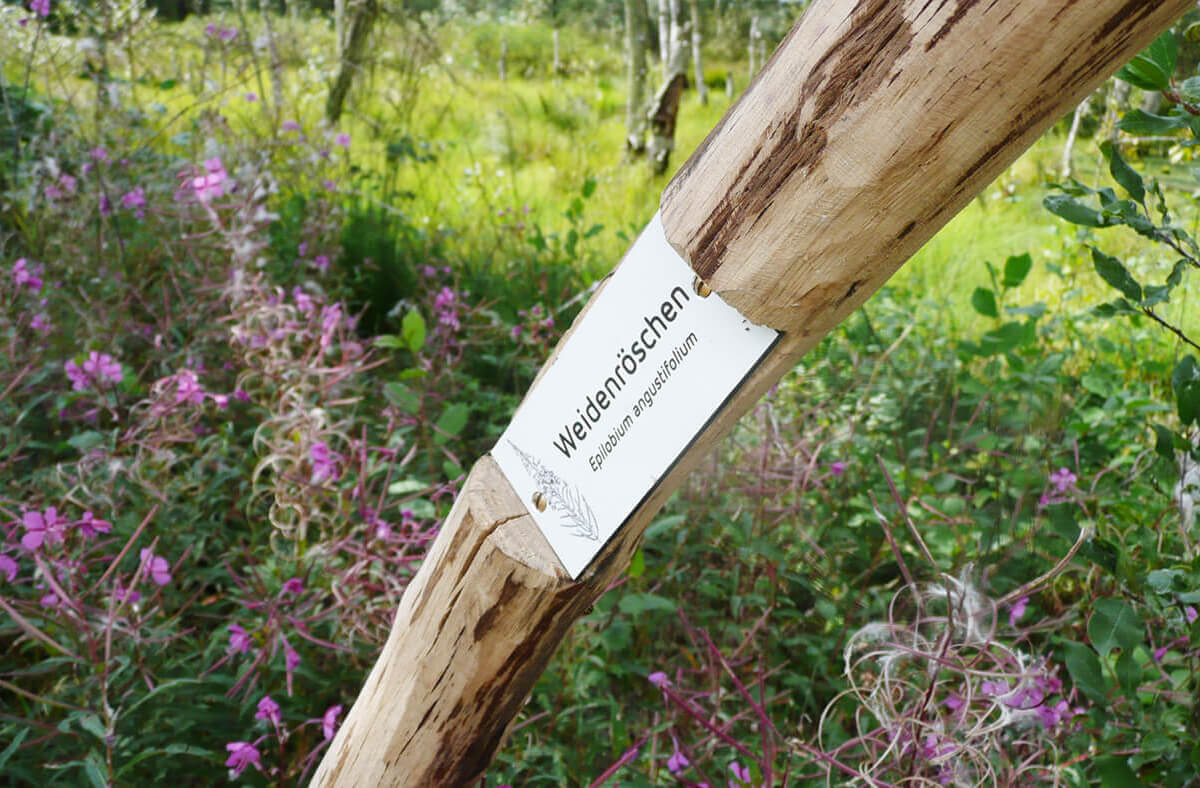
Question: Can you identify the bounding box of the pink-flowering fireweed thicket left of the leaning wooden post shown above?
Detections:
[0,1,554,786]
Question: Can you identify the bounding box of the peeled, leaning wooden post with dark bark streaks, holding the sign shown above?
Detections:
[313,0,1192,788]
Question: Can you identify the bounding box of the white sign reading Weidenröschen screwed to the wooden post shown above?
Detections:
[492,213,779,577]
